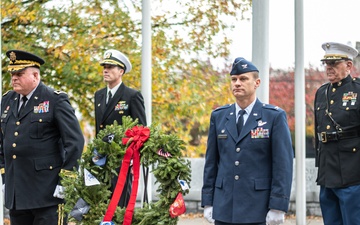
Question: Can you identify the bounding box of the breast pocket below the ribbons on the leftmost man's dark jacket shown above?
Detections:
[30,113,52,139]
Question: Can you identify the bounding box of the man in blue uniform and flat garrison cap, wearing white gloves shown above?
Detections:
[201,57,293,225]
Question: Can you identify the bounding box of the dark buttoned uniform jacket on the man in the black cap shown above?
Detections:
[0,82,84,210]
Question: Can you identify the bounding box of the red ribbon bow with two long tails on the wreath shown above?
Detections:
[103,126,150,225]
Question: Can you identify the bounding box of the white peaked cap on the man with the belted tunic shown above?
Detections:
[321,42,359,61]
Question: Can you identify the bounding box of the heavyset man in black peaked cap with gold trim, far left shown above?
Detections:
[0,50,84,225]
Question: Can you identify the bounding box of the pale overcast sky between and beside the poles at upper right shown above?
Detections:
[231,0,360,69]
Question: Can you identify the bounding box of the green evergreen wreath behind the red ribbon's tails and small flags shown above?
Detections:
[60,117,191,225]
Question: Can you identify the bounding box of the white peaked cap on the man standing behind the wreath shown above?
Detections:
[100,49,132,73]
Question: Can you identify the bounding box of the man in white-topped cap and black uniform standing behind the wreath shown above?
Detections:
[95,49,146,207]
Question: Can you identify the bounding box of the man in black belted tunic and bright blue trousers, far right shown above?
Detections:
[314,42,360,225]
